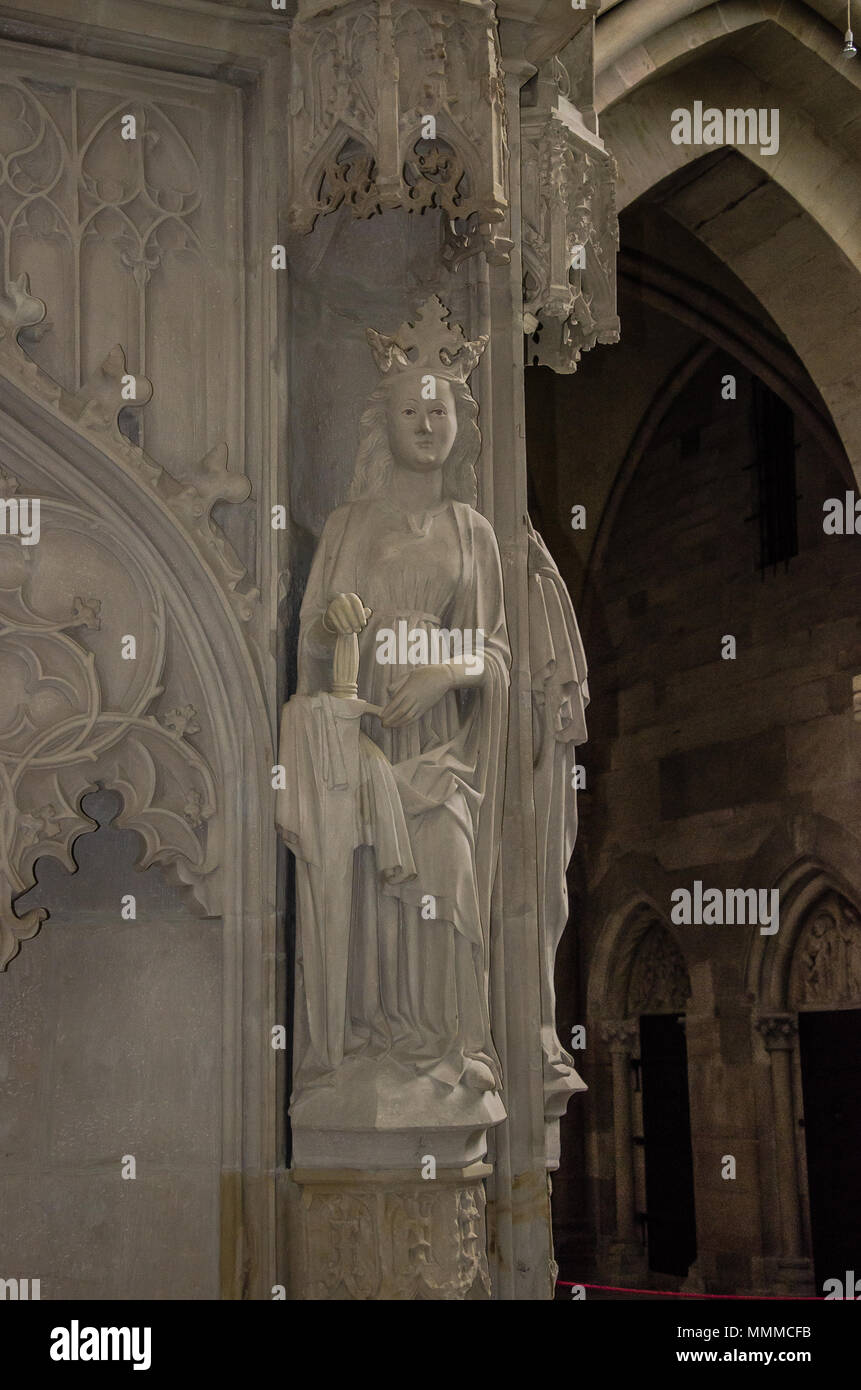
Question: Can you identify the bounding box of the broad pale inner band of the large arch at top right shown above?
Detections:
[602,50,861,478]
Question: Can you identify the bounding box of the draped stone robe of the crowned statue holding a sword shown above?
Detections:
[278,498,510,1098]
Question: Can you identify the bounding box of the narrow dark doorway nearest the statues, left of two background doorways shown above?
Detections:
[640,1013,697,1275]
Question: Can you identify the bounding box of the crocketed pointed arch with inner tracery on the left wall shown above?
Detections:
[0,296,278,1298]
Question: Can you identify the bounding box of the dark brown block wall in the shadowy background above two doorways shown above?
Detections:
[555,344,861,1291]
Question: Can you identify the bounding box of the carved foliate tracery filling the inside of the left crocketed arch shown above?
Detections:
[0,485,220,969]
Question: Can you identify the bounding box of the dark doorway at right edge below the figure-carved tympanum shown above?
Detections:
[798,1009,861,1293]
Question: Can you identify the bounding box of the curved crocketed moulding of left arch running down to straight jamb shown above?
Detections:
[0,284,278,1298]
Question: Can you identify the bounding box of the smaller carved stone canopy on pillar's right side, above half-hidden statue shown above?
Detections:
[520,60,619,373]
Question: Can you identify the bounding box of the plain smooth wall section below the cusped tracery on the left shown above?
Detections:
[0,792,223,1300]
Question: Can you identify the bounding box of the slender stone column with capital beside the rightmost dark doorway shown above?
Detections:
[757,1013,810,1290]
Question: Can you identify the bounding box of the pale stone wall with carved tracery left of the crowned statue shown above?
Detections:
[0,3,279,1300]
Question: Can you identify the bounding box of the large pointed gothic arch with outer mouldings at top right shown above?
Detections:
[597,21,861,489]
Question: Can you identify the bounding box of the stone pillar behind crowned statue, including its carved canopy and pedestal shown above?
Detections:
[281,0,606,1300]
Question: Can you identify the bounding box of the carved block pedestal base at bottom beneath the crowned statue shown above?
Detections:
[288,1163,491,1301]
